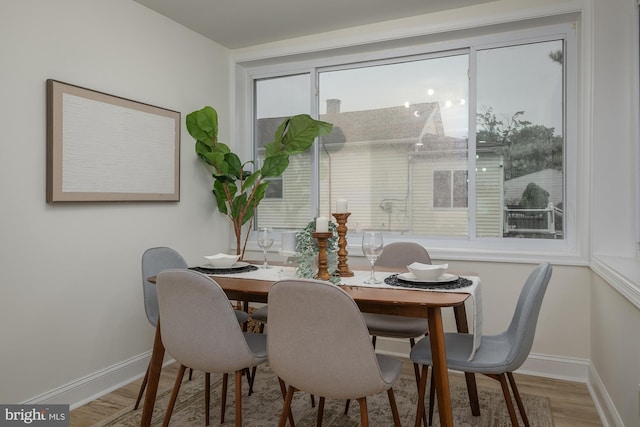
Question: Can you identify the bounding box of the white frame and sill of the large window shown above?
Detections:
[234,14,588,265]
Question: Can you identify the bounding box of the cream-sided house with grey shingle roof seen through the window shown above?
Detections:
[256,99,503,237]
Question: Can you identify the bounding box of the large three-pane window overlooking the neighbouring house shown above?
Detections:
[253,26,575,249]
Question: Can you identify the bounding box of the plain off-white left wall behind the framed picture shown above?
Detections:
[0,0,230,403]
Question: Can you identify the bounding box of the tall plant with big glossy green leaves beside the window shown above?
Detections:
[186,106,333,259]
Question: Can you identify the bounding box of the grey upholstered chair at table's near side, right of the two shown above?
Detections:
[267,279,402,426]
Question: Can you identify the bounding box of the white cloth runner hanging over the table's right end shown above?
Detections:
[212,266,482,360]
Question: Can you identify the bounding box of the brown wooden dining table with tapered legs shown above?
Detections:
[141,270,480,427]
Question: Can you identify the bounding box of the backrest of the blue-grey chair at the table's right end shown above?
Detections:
[504,262,553,372]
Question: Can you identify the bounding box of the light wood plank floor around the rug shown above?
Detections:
[70,364,602,427]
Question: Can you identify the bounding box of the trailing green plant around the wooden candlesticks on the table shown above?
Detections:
[296,219,340,283]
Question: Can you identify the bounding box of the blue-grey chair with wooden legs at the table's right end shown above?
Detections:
[411,263,552,426]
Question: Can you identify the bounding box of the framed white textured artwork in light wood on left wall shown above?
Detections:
[46,79,180,203]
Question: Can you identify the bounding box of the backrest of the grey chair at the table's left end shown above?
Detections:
[142,246,188,327]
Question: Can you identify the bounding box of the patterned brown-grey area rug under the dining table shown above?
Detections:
[95,365,553,427]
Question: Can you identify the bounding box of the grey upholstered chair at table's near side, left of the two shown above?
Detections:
[156,270,267,427]
